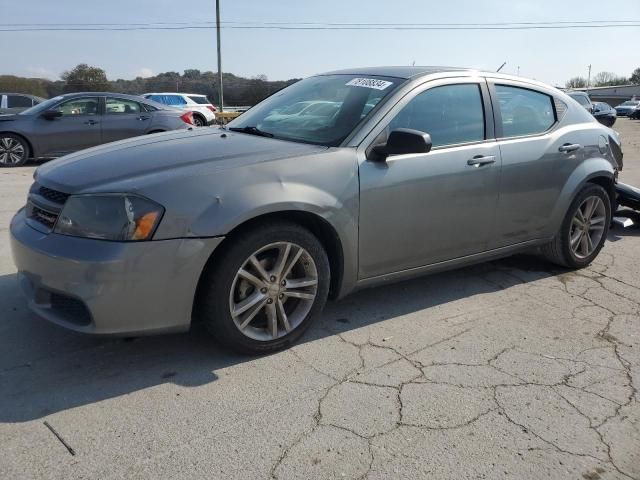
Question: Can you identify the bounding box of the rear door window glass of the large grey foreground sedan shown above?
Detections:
[496,85,556,137]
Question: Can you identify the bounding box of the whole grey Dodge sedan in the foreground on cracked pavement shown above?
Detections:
[11,67,622,352]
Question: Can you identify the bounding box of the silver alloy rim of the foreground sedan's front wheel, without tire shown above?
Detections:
[229,242,318,341]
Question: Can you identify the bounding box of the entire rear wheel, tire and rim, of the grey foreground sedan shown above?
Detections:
[542,183,611,269]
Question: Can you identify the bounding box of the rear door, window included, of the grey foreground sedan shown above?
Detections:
[489,80,585,248]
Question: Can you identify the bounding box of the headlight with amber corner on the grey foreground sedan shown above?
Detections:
[54,194,164,241]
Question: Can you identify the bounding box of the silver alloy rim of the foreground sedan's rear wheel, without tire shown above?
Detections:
[569,195,607,260]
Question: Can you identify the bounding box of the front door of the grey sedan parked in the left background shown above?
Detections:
[36,96,102,156]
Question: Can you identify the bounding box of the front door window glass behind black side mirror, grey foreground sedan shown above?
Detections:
[389,83,485,147]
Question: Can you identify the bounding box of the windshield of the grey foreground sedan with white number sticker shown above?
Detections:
[229,75,404,146]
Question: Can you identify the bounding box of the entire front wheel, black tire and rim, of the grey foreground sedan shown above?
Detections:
[195,222,330,354]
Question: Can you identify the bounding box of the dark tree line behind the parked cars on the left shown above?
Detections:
[0,64,299,105]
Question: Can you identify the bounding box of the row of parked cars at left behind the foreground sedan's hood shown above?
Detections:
[0,92,216,167]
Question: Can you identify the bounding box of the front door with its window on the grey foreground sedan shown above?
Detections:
[359,79,501,279]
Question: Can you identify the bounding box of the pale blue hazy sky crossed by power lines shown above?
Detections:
[0,0,640,85]
